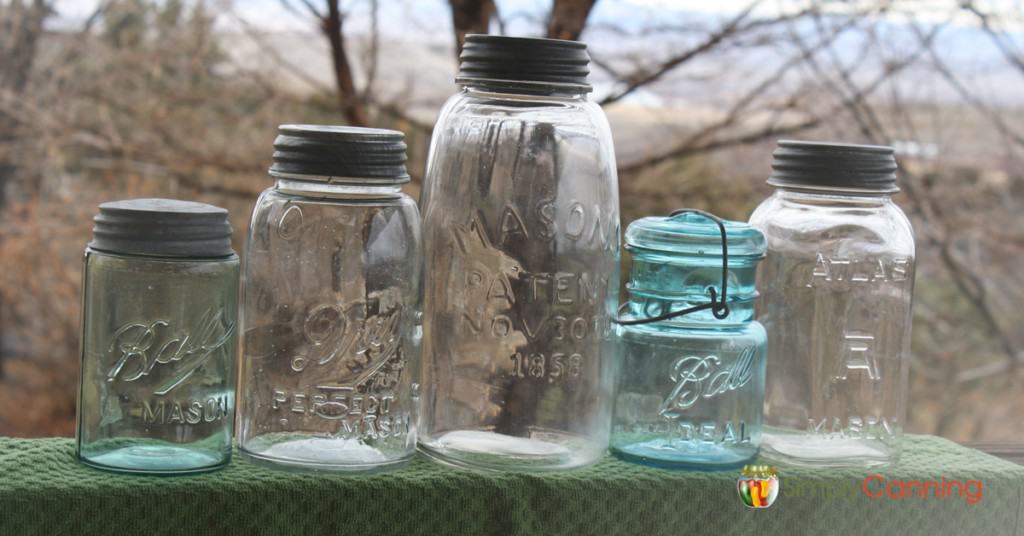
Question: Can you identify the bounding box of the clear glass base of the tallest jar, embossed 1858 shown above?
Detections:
[420,430,604,472]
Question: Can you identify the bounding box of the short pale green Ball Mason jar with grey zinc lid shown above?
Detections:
[76,199,239,475]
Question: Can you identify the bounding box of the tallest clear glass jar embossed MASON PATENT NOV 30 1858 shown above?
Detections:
[420,35,620,470]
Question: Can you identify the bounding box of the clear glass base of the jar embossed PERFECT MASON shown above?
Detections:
[239,436,415,473]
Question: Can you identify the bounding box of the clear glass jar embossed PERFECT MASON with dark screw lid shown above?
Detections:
[238,125,422,471]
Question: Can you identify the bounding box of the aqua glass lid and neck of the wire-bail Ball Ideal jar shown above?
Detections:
[618,209,766,325]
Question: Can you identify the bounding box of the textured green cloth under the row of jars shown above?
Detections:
[0,436,1024,536]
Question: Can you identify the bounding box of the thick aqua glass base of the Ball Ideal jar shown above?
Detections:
[609,440,758,470]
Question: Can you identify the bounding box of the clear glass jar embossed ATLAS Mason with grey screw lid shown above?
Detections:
[751,140,914,466]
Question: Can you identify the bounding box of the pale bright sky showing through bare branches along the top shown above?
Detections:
[50,0,1024,102]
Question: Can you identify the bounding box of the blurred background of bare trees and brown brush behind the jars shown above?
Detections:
[0,0,1024,444]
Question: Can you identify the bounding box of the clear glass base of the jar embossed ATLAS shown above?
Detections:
[761,429,899,467]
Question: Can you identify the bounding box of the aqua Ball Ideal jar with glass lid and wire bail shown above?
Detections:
[611,210,766,468]
